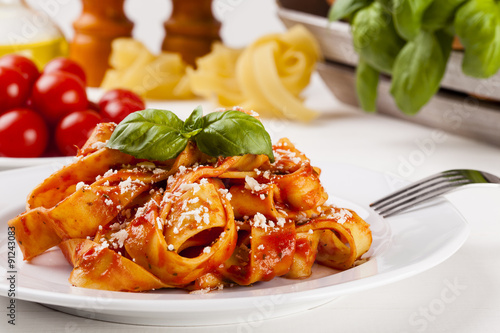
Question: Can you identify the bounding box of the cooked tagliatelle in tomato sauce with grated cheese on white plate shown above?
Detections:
[5,110,372,291]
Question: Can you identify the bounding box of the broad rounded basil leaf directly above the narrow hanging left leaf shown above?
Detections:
[352,2,405,74]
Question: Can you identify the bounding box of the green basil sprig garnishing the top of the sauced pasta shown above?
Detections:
[107,107,274,162]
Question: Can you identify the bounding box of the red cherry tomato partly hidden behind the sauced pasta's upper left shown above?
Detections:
[55,110,102,156]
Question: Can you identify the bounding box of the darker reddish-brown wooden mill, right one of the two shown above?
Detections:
[162,0,221,66]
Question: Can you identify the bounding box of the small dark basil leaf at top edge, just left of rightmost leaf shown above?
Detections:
[422,0,467,31]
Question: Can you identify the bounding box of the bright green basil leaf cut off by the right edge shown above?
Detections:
[455,0,500,78]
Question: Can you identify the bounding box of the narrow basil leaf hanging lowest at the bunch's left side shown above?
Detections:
[356,58,380,112]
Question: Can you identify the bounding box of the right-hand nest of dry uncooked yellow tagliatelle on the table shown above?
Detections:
[188,25,321,122]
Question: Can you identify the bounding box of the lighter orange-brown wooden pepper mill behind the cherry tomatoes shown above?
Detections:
[69,0,134,87]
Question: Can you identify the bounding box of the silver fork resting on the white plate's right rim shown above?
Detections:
[370,169,500,217]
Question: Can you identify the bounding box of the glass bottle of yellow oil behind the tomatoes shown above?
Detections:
[0,0,68,69]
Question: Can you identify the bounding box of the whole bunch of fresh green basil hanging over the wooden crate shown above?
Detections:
[329,0,500,115]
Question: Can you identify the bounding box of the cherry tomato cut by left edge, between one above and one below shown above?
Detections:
[0,67,30,113]
